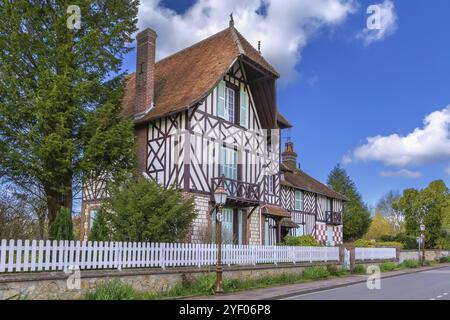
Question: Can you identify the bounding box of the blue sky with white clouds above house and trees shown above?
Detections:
[124,0,450,208]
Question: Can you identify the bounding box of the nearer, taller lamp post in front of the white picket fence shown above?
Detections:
[214,186,227,294]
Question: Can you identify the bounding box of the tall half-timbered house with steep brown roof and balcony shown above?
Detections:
[81,21,342,244]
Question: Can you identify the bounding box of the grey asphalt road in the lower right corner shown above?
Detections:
[287,267,450,300]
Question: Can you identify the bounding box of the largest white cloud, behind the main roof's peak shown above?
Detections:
[138,0,356,82]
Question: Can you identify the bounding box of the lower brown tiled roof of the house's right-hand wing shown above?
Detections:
[281,167,348,201]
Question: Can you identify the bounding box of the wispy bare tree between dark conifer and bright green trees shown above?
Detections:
[375,191,405,234]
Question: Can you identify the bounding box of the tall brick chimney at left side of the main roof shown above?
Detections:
[134,28,157,117]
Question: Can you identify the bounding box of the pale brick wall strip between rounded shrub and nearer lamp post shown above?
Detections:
[191,195,210,243]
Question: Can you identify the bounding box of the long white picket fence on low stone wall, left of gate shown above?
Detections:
[0,240,339,272]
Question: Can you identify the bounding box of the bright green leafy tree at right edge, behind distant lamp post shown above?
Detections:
[395,180,450,248]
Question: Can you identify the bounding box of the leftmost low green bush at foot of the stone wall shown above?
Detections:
[85,280,139,300]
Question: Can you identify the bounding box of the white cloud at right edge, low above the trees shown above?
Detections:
[343,105,450,167]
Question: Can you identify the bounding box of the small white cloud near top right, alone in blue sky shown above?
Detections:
[356,0,398,45]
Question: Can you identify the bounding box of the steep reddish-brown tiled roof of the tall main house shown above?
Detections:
[123,27,279,122]
